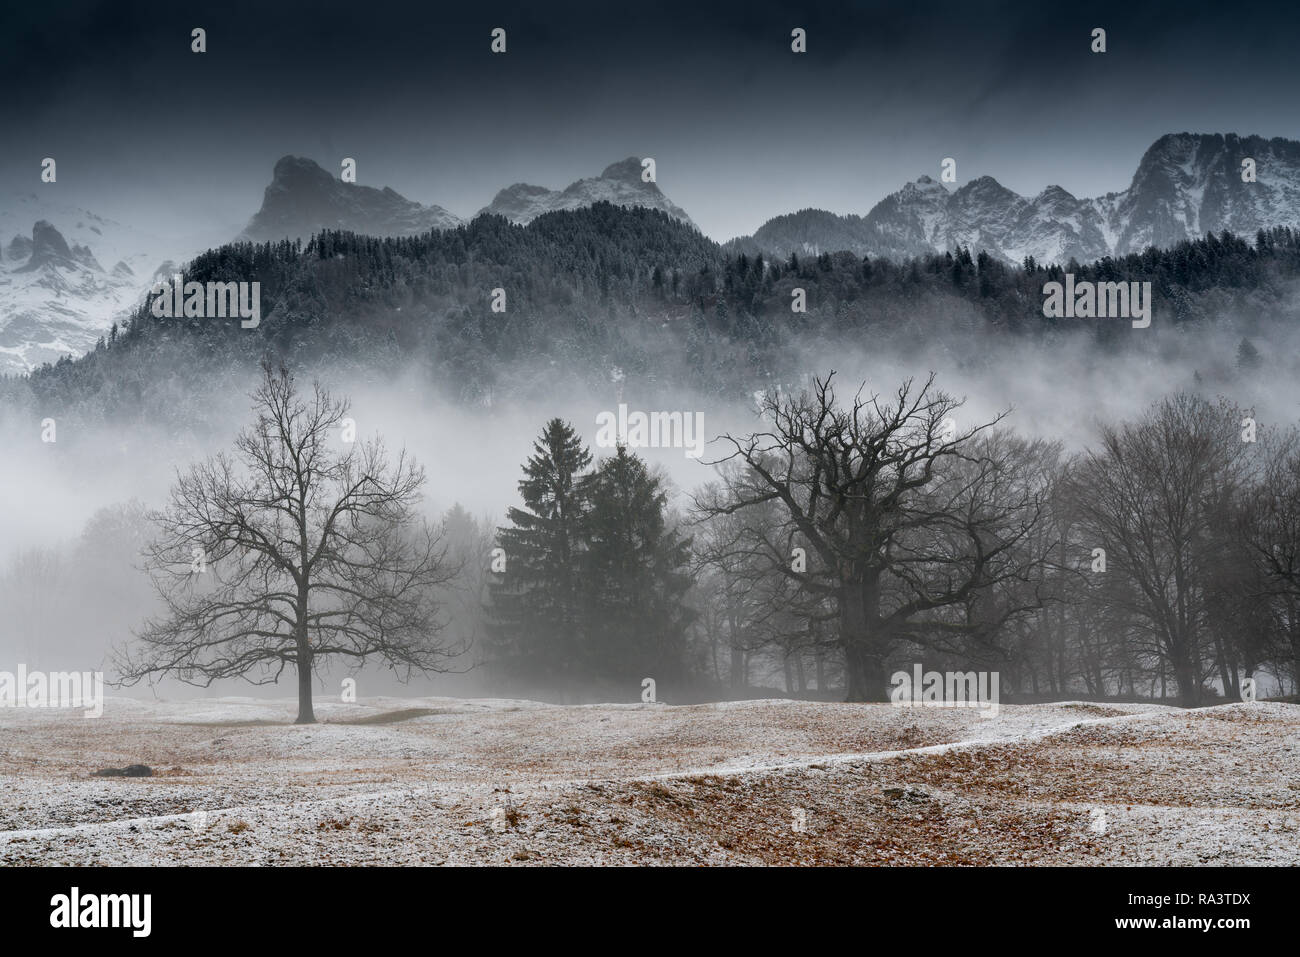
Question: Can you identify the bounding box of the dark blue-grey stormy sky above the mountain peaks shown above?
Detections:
[0,0,1300,239]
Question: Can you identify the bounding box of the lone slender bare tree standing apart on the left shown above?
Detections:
[117,364,464,724]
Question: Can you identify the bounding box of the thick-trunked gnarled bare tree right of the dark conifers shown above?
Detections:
[696,373,1043,701]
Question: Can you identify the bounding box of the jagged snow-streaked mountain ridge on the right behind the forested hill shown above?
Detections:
[738,133,1300,263]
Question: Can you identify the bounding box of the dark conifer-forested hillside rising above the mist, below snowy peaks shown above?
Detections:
[0,203,1300,416]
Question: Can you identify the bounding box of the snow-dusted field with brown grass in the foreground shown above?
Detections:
[0,698,1300,865]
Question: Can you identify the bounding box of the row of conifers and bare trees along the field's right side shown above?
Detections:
[459,376,1300,705]
